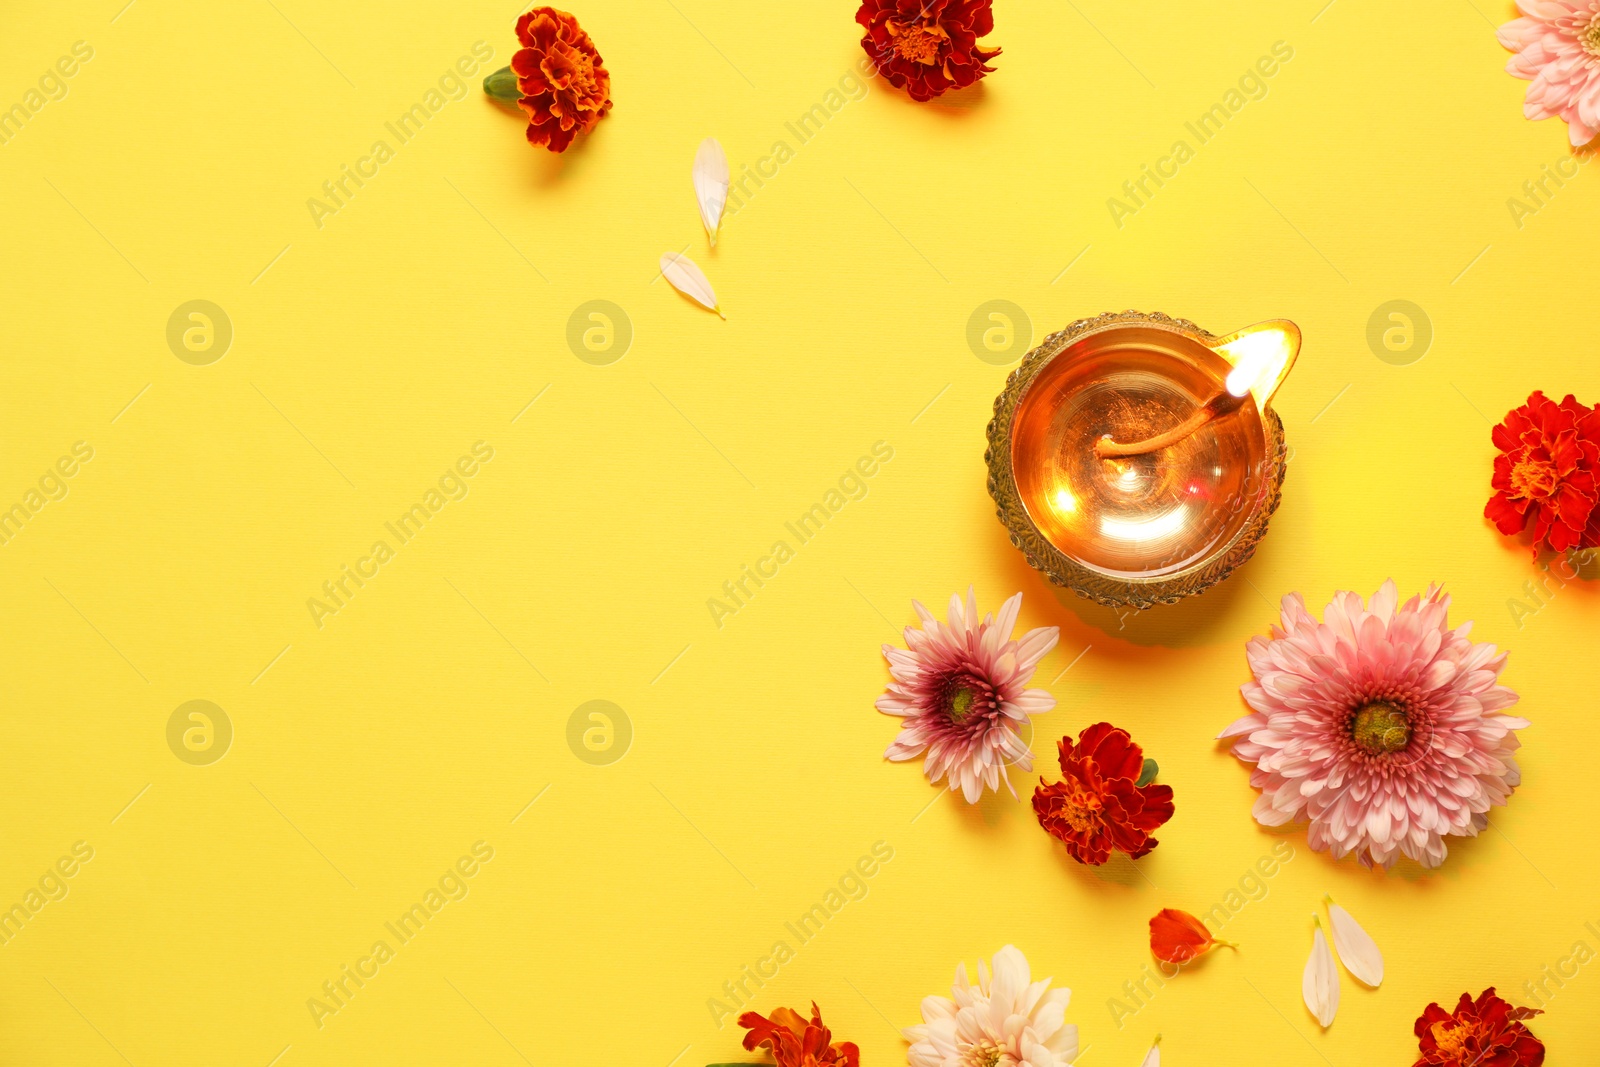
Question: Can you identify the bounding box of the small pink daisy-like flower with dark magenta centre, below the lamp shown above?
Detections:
[877,589,1059,805]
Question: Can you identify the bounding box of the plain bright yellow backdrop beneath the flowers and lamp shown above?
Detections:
[0,0,1600,1067]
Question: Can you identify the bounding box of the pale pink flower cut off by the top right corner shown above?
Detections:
[1499,0,1600,147]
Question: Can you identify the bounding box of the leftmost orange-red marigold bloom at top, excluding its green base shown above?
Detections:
[510,8,611,152]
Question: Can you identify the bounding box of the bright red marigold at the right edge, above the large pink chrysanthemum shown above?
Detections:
[1483,392,1600,555]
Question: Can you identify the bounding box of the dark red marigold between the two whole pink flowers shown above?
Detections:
[1034,723,1173,867]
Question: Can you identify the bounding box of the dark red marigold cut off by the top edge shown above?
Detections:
[856,0,1000,101]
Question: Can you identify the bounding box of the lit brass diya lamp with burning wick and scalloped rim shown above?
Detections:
[986,312,1301,608]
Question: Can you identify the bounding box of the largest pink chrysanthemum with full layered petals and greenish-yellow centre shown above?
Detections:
[1219,581,1528,869]
